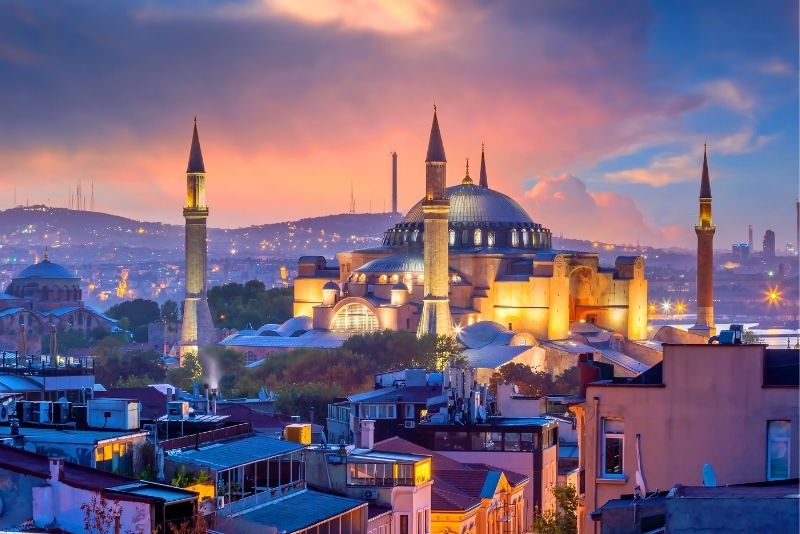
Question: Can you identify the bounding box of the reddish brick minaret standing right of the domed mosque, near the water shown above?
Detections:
[689,147,717,337]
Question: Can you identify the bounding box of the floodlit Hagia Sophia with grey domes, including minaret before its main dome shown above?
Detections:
[294,111,647,340]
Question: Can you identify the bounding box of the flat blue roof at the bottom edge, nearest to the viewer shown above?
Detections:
[235,490,367,533]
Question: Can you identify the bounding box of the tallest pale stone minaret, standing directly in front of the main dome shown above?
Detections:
[417,106,453,337]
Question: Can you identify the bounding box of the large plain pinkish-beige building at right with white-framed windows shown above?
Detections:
[571,344,800,531]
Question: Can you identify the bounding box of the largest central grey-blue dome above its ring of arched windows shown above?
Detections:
[403,184,533,224]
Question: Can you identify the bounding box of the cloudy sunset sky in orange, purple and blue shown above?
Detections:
[0,1,798,249]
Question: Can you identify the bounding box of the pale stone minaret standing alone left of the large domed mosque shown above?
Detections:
[180,119,215,356]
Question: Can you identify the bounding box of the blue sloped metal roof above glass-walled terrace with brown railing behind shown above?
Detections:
[168,436,304,471]
